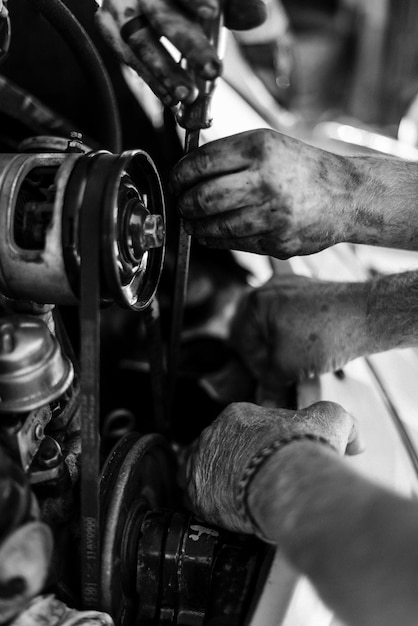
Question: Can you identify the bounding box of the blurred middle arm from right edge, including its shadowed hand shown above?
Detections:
[230,271,418,388]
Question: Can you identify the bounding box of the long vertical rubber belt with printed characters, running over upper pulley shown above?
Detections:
[80,154,114,610]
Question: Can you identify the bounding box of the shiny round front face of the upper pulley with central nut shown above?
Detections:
[102,150,165,311]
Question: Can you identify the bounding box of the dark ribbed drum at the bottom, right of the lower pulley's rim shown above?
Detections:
[134,510,272,626]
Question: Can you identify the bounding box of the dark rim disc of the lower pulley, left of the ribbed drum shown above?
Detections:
[100,433,176,626]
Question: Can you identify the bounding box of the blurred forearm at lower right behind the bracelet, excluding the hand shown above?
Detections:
[248,442,418,626]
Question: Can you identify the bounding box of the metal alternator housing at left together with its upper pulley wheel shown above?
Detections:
[0,150,165,310]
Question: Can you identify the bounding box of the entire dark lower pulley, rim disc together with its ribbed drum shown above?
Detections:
[100,433,272,626]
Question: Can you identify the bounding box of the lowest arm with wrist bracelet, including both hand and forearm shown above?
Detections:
[186,402,418,626]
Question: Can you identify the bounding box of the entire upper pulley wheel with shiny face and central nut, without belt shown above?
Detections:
[62,150,165,311]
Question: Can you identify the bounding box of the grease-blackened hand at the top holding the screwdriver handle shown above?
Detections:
[97,0,267,106]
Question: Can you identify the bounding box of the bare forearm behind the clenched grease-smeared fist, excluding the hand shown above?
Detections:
[344,157,418,250]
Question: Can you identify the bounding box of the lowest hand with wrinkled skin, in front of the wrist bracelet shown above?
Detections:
[186,402,360,533]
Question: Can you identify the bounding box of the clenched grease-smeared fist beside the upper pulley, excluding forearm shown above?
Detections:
[171,129,356,258]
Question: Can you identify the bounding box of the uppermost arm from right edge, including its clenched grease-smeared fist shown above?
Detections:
[172,129,418,258]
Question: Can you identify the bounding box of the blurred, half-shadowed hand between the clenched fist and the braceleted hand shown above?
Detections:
[230,274,375,391]
